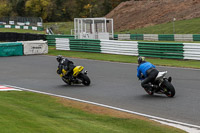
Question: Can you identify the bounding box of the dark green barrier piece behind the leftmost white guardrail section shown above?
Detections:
[46,35,74,46]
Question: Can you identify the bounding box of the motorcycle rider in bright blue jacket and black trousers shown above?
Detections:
[137,57,159,91]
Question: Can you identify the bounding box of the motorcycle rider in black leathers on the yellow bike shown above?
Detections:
[56,55,76,80]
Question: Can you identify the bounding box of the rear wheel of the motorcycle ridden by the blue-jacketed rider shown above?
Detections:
[162,80,176,97]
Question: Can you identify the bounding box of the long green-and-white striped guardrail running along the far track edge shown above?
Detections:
[56,38,200,60]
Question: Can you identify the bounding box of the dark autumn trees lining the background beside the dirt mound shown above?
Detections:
[0,0,128,22]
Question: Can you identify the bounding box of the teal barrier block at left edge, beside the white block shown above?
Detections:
[0,43,23,56]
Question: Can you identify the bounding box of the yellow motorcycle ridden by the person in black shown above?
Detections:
[60,66,90,86]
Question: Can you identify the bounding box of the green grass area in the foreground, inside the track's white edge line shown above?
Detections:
[0,91,184,133]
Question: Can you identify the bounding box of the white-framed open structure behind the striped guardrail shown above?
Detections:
[74,18,114,40]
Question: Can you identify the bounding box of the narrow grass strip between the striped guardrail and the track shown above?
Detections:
[48,46,200,69]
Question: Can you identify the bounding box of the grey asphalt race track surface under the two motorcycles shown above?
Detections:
[0,55,200,126]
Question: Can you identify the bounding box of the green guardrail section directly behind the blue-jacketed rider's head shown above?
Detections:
[138,42,184,59]
